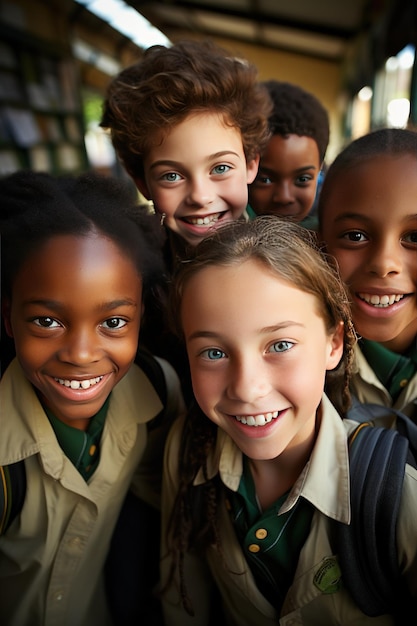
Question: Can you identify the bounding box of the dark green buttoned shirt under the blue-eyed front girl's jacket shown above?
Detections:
[227,457,314,612]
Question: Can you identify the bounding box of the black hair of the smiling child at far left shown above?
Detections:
[0,170,167,369]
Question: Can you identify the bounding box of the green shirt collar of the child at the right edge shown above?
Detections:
[359,339,417,400]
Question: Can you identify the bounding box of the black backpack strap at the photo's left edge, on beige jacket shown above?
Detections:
[0,461,26,535]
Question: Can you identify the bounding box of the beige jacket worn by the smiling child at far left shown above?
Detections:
[0,360,182,626]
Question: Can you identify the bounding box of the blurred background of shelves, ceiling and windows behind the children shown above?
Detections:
[0,0,417,176]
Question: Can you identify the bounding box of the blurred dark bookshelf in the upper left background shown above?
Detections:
[0,24,88,176]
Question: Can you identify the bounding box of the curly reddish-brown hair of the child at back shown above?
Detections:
[100,41,272,179]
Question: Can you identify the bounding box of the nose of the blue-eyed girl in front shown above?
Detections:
[227,358,271,404]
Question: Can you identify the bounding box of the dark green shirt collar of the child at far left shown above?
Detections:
[44,396,110,482]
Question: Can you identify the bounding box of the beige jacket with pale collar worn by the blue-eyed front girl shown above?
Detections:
[162,396,417,626]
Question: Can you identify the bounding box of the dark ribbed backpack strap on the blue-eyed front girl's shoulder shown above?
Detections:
[338,422,408,616]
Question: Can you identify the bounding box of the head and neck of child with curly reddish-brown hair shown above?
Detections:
[101,41,271,265]
